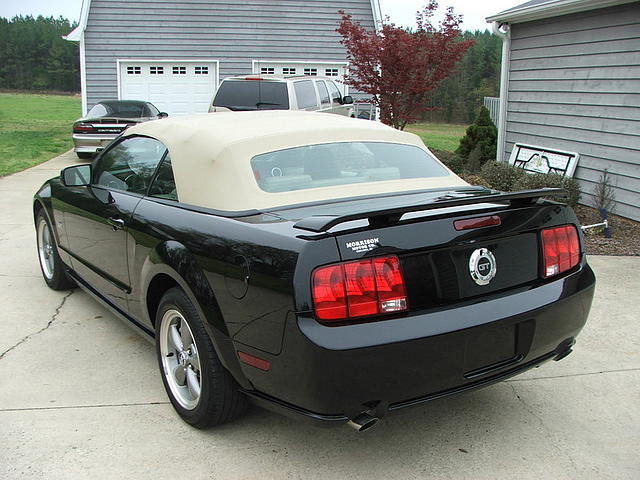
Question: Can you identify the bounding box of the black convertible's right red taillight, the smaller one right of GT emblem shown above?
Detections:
[541,225,580,278]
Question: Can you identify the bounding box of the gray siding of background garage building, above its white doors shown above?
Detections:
[85,0,374,108]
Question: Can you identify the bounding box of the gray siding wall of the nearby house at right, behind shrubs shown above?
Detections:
[505,2,640,220]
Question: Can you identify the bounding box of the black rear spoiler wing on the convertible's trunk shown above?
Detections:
[293,188,567,233]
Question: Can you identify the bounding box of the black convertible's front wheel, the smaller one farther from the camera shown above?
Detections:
[36,209,76,290]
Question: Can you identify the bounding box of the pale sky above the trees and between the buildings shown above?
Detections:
[0,0,525,30]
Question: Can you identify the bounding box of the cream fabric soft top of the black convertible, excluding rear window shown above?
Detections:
[126,110,467,211]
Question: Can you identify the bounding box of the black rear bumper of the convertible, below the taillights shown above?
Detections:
[242,263,595,424]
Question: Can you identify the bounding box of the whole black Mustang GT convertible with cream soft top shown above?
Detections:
[33,112,595,430]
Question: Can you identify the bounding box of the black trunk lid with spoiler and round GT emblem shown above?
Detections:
[278,188,566,311]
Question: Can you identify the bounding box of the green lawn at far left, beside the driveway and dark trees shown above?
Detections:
[0,93,81,176]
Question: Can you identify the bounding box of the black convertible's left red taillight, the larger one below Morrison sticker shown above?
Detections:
[311,255,407,321]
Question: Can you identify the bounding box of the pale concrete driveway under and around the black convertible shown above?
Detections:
[0,153,640,480]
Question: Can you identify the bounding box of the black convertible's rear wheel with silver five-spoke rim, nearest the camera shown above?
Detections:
[156,288,247,428]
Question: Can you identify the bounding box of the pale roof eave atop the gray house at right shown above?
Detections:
[486,0,637,23]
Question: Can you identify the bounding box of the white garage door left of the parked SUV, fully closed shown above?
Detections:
[119,60,218,115]
